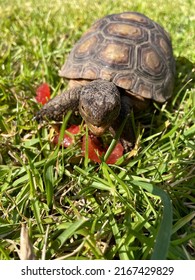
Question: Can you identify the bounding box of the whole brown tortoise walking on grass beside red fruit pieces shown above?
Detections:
[35,12,175,151]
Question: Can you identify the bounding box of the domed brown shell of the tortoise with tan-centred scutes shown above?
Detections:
[59,12,175,102]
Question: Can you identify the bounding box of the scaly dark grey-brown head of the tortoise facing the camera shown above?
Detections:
[79,80,121,136]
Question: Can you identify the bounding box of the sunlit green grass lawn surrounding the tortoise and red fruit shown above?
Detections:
[0,0,195,260]
